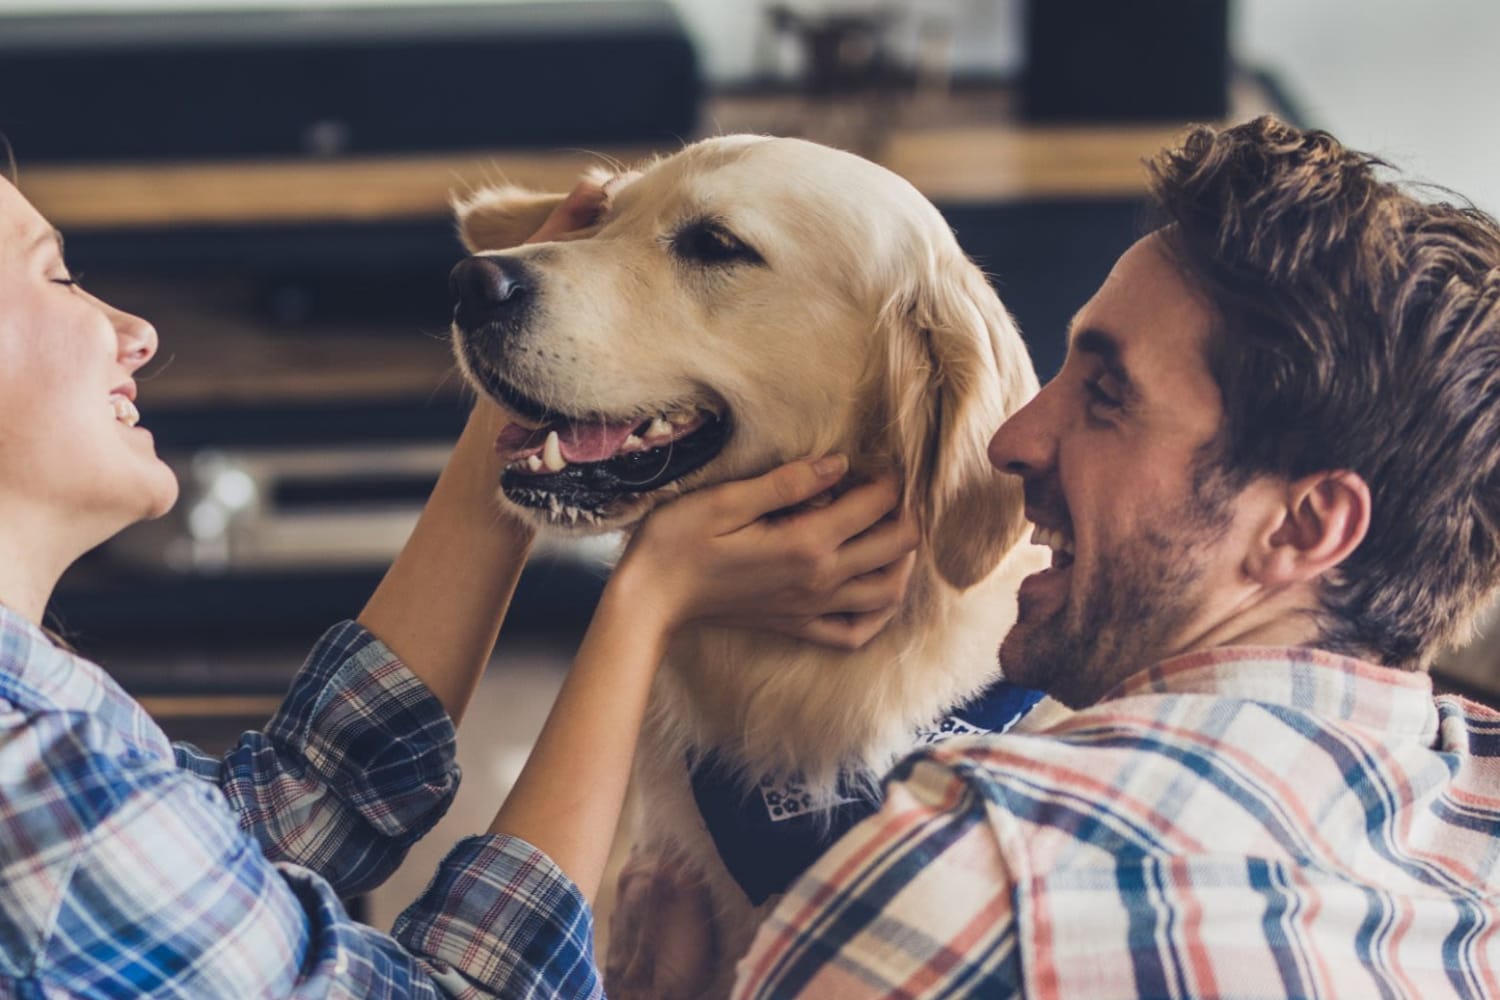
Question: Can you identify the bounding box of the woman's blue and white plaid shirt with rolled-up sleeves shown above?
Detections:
[0,609,602,1000]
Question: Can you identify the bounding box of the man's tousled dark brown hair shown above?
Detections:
[1148,117,1500,669]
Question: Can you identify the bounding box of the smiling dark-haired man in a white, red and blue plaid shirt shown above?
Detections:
[737,118,1500,999]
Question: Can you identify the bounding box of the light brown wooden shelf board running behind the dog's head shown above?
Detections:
[21,81,1271,231]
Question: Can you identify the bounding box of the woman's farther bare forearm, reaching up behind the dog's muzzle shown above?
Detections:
[359,402,531,724]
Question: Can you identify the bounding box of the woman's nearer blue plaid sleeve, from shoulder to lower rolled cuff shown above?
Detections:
[0,714,602,1000]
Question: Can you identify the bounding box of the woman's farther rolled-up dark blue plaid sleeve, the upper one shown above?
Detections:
[173,622,459,897]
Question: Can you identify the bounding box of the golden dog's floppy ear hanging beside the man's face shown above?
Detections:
[879,249,1037,589]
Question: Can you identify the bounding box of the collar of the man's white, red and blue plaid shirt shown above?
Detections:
[1103,646,1437,742]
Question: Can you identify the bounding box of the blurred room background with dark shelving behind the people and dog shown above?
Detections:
[0,0,1500,925]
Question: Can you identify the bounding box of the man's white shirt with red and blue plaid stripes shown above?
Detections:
[735,649,1500,1000]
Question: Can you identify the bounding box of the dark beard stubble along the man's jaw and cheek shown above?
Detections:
[1001,454,1238,709]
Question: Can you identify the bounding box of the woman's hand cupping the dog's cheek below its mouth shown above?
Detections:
[611,456,918,649]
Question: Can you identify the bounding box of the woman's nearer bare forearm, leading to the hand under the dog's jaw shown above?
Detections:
[489,580,668,903]
